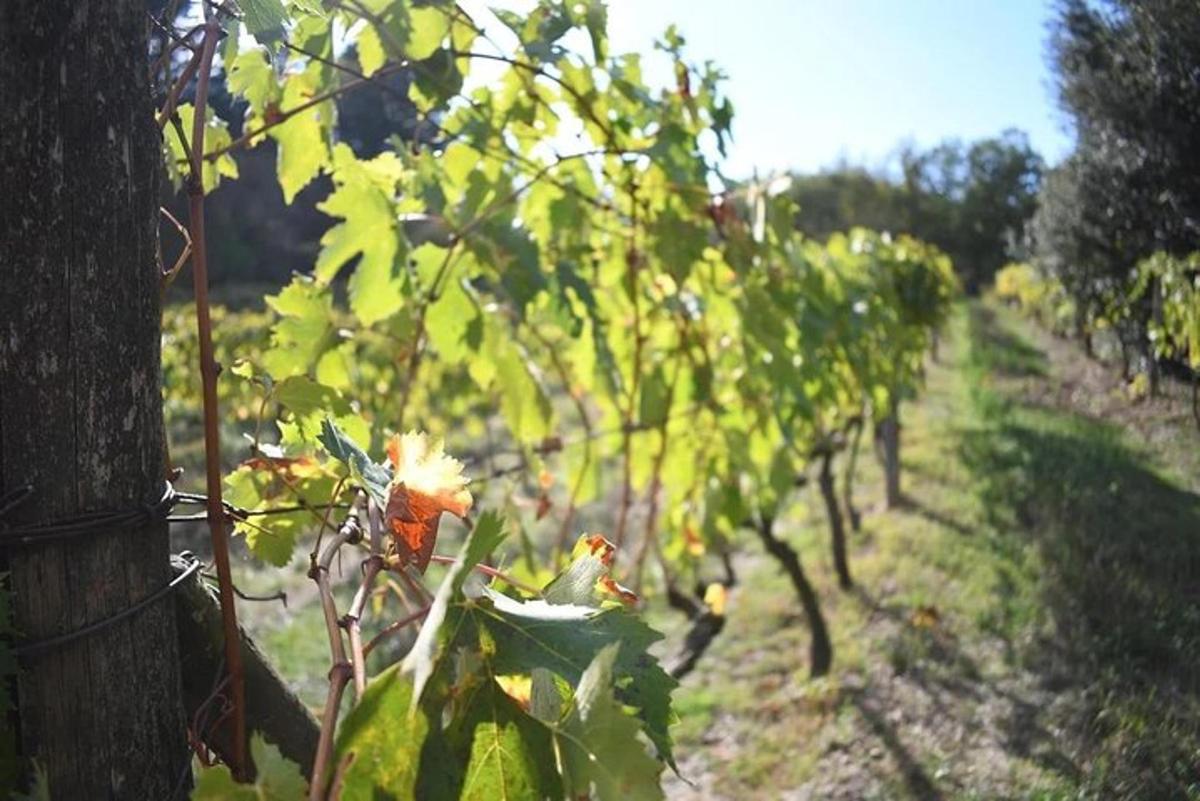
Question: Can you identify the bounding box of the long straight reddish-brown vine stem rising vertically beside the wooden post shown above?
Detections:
[188,15,250,781]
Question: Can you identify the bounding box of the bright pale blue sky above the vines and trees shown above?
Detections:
[463,0,1070,176]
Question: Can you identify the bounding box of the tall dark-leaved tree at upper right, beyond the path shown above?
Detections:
[1030,0,1200,391]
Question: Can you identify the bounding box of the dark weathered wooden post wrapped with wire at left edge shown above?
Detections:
[0,0,190,801]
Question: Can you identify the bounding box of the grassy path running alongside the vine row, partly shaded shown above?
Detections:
[668,305,1200,800]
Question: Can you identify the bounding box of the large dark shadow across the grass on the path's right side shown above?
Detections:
[960,303,1200,799]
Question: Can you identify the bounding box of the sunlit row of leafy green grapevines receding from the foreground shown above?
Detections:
[157,4,955,799]
